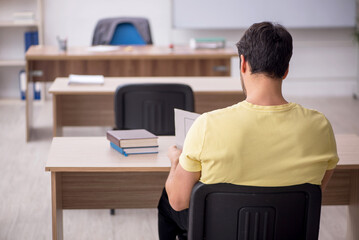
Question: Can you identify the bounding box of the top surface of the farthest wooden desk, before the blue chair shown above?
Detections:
[26,45,238,60]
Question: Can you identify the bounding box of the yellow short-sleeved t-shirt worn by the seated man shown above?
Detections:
[179,101,339,186]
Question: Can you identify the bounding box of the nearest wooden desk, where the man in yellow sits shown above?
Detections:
[46,135,359,240]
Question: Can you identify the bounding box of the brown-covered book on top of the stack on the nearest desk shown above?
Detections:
[106,129,158,148]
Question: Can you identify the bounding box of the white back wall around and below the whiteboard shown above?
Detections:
[0,0,358,97]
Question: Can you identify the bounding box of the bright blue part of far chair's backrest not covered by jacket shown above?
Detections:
[110,23,146,45]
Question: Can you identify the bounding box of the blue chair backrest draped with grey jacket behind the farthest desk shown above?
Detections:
[92,17,152,45]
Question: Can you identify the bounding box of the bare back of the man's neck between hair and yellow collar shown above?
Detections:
[246,74,288,106]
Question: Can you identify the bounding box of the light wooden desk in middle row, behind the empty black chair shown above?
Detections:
[50,77,245,136]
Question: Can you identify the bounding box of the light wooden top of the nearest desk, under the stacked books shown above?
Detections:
[45,134,359,172]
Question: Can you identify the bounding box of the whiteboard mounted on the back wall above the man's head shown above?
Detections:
[172,0,356,29]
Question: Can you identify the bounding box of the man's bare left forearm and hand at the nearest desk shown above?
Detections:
[166,146,201,211]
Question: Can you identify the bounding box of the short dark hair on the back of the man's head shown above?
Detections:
[236,22,293,78]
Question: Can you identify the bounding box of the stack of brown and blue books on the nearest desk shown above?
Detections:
[106,129,158,157]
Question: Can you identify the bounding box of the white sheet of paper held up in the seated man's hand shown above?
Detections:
[175,108,200,149]
